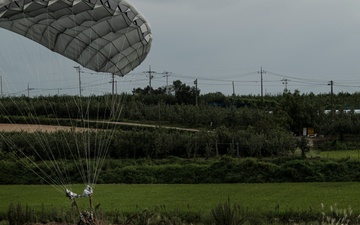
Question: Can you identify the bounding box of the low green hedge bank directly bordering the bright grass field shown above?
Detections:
[0,157,360,184]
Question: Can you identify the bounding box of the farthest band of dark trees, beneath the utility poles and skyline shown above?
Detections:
[0,88,360,138]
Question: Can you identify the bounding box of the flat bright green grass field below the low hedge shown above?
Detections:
[0,183,360,215]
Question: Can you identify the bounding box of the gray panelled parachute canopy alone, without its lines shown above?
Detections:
[0,0,152,76]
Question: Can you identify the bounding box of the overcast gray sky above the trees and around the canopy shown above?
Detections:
[0,0,360,95]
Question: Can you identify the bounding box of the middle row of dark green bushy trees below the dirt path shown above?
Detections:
[0,127,301,161]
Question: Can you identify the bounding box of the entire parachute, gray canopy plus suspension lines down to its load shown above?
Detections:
[0,0,152,221]
